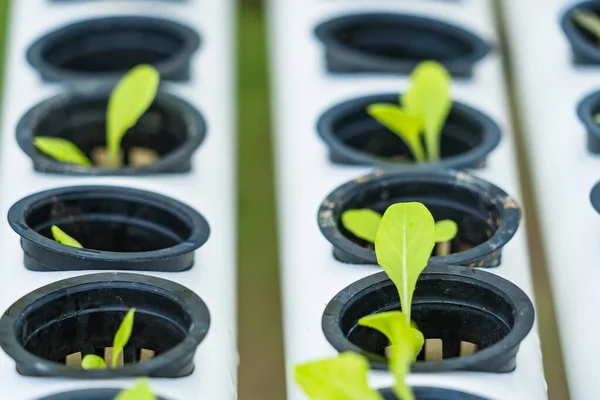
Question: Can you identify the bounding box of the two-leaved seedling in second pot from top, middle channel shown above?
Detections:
[367,61,452,163]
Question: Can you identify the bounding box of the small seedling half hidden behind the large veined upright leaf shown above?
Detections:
[342,208,458,256]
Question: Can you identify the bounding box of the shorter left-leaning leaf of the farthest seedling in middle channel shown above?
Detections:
[367,104,426,163]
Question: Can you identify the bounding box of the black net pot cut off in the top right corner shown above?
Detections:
[560,1,600,65]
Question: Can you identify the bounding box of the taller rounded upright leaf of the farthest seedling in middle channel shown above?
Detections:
[401,61,452,162]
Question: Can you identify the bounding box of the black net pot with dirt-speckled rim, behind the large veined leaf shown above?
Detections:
[318,170,521,267]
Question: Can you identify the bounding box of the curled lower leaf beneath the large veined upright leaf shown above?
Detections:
[358,311,425,400]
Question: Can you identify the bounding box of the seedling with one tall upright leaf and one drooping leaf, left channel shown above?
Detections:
[33,64,160,168]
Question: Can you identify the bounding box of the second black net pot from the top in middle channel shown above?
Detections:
[317,93,501,170]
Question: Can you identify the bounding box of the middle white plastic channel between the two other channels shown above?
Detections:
[269,0,547,400]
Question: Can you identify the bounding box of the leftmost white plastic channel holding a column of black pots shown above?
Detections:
[0,0,237,400]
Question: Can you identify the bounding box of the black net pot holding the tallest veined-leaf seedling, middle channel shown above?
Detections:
[322,265,534,372]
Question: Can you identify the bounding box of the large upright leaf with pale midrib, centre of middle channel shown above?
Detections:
[375,203,435,324]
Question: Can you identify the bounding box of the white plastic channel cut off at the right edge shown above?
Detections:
[502,0,600,400]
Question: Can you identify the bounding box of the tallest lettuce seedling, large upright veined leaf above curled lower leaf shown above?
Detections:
[359,202,438,400]
